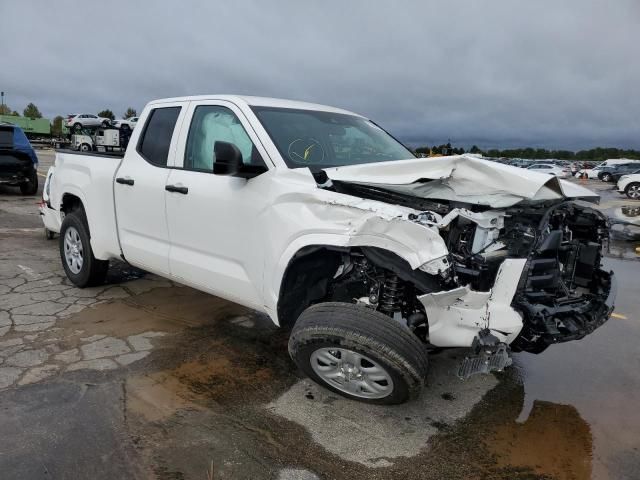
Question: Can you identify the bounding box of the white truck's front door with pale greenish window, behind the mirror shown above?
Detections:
[167,101,272,309]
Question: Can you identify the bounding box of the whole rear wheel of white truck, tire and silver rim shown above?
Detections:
[60,210,109,288]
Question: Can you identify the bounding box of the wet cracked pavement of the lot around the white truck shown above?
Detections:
[0,152,640,479]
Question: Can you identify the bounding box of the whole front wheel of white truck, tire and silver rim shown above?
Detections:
[289,303,427,404]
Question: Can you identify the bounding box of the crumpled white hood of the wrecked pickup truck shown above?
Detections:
[324,155,600,208]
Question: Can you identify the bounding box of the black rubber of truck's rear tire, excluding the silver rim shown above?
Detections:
[59,209,109,288]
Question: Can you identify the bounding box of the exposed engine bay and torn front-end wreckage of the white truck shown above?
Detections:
[318,181,615,353]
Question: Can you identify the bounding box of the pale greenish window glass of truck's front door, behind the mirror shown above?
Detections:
[184,105,265,172]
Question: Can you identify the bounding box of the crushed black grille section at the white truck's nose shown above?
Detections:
[511,202,616,353]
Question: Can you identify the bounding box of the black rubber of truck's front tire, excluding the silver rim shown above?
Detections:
[289,302,428,405]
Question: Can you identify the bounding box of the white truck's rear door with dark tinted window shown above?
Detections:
[114,103,186,275]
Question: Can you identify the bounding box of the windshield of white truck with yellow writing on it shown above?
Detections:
[252,107,415,171]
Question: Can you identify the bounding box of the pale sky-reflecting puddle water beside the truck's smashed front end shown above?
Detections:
[516,259,640,480]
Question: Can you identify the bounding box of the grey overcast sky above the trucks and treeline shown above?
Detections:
[0,0,640,149]
